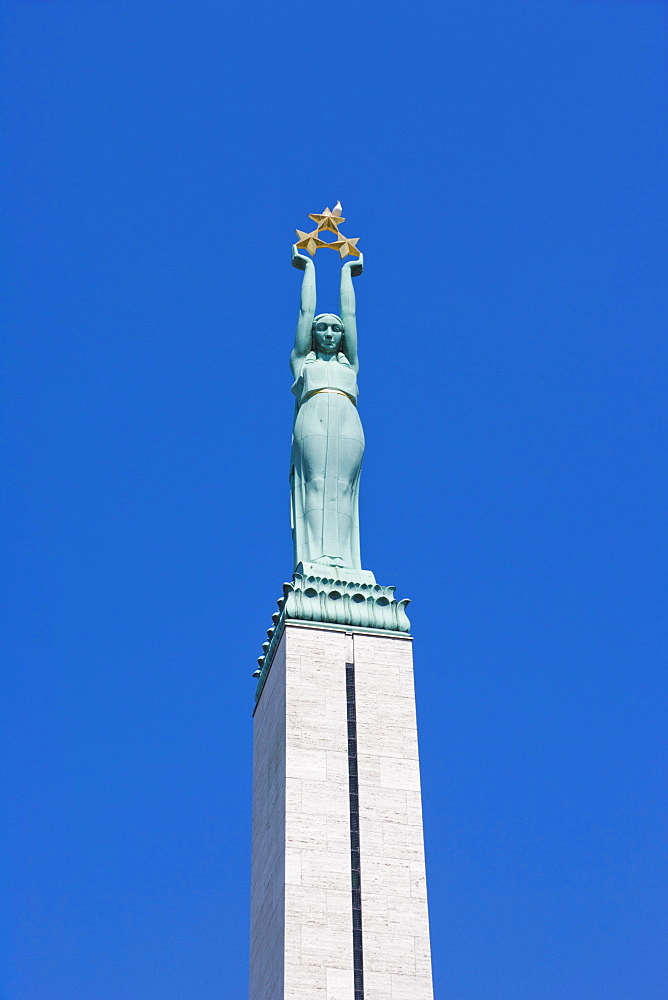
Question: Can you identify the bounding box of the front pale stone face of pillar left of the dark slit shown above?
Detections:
[284,626,353,1000]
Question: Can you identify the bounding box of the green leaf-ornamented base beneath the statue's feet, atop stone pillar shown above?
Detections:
[253,562,411,701]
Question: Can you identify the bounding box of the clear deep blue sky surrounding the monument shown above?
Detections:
[0,0,668,1000]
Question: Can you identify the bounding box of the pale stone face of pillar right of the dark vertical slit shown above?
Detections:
[353,635,433,1000]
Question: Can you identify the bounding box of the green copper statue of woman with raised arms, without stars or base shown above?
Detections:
[290,247,364,569]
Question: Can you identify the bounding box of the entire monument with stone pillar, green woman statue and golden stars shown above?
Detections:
[250,204,433,1000]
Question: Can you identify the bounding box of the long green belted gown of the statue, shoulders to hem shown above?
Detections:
[290,351,364,569]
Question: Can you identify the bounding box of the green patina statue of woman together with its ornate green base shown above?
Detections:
[254,246,410,700]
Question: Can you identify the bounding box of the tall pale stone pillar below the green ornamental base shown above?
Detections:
[250,619,433,1000]
